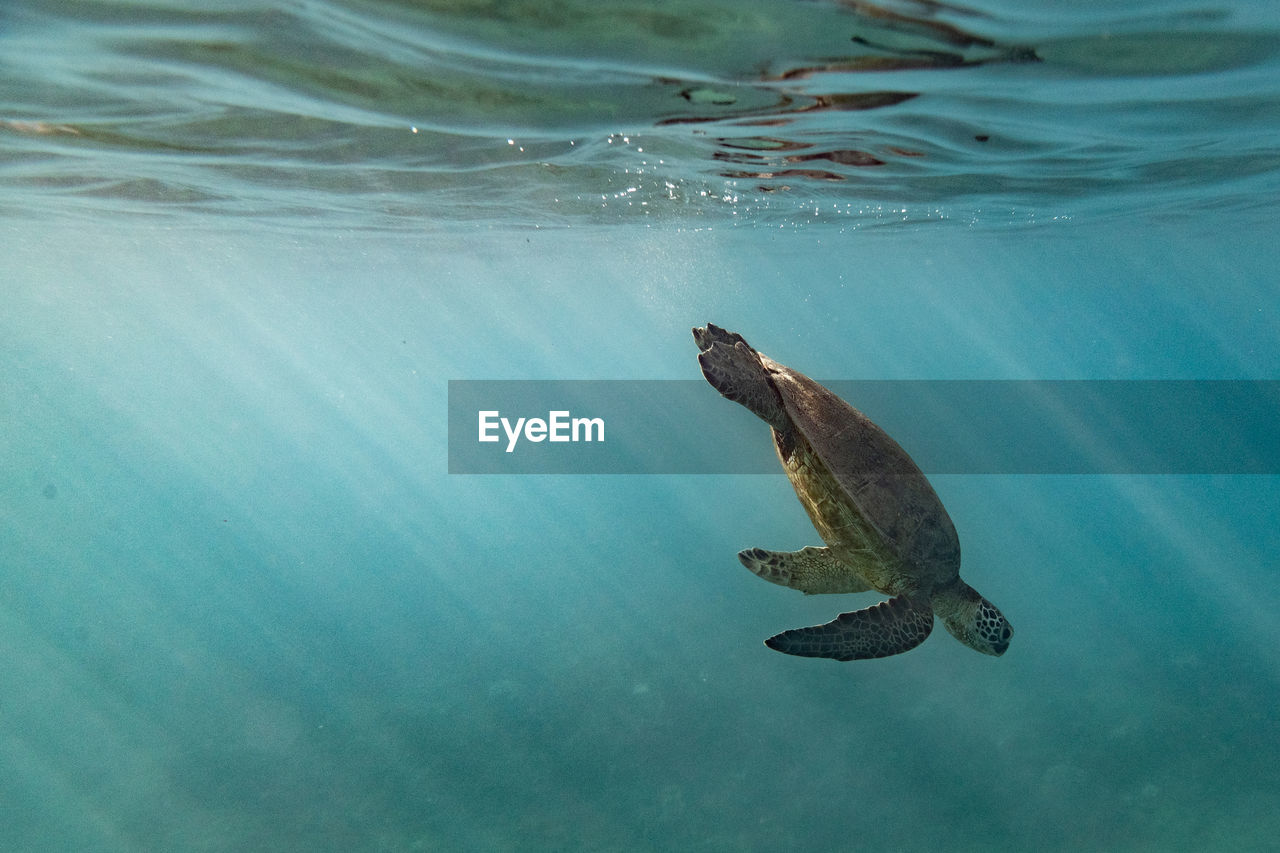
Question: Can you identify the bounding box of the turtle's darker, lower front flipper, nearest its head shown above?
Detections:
[764,596,933,661]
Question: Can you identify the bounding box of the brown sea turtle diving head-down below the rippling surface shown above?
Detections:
[694,323,1014,661]
